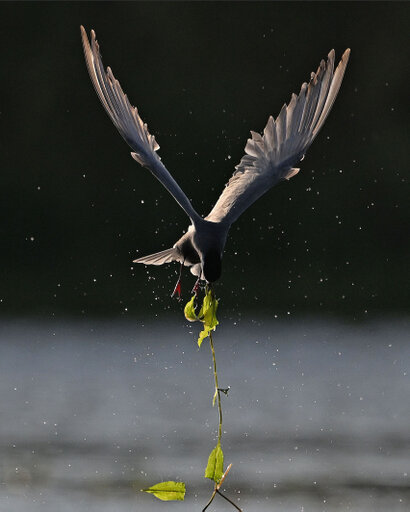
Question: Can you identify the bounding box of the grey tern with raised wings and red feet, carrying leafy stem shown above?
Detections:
[81,26,350,295]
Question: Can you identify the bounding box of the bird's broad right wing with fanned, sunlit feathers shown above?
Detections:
[206,49,350,224]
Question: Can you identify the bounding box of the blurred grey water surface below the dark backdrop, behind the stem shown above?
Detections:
[0,319,410,512]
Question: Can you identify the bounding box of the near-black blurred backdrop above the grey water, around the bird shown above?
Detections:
[0,2,410,319]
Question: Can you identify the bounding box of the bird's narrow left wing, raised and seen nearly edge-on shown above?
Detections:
[81,26,199,220]
